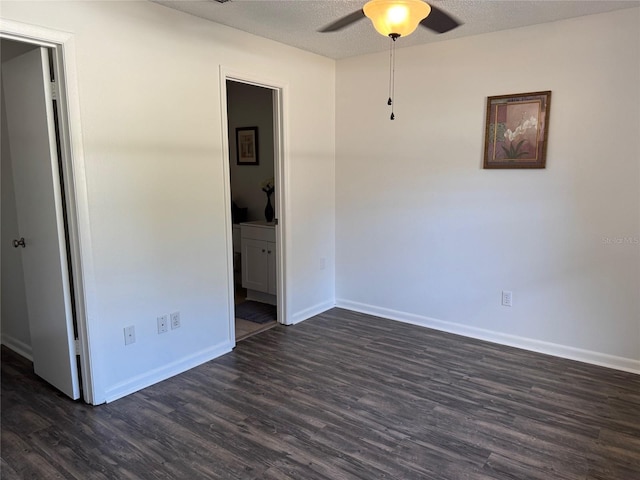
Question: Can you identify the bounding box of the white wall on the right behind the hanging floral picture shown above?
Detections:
[336,8,640,371]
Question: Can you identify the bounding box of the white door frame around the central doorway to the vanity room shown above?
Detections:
[220,65,292,345]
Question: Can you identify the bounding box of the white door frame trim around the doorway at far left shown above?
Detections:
[0,19,96,405]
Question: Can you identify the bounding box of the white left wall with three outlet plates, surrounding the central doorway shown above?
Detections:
[1,1,335,403]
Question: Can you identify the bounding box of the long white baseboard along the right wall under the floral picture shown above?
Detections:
[336,299,640,374]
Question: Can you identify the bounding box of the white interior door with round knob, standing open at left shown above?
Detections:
[2,48,80,399]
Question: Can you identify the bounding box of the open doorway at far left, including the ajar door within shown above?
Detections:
[0,32,93,403]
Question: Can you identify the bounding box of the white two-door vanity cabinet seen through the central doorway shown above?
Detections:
[240,222,277,304]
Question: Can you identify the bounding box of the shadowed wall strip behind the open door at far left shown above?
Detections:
[0,65,31,358]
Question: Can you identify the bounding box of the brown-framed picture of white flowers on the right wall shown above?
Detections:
[484,91,551,168]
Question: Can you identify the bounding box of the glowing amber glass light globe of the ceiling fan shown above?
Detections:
[363,0,431,37]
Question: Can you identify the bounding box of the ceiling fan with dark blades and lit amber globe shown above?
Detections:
[319,0,461,40]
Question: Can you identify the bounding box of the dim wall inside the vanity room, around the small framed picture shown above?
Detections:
[227,82,275,221]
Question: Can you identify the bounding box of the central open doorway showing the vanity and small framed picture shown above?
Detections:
[226,80,278,342]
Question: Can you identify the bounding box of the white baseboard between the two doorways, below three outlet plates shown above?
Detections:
[105,342,234,403]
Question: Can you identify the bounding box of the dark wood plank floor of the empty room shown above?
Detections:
[1,309,640,480]
